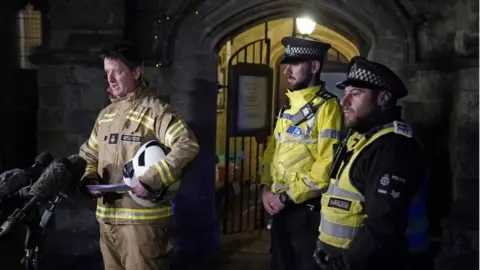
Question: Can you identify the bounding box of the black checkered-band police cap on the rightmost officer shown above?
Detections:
[337,56,408,99]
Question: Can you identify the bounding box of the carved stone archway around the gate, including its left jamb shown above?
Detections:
[161,0,413,252]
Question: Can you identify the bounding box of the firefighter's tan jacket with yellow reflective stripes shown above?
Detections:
[80,82,199,224]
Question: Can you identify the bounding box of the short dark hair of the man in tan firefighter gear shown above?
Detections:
[100,41,143,69]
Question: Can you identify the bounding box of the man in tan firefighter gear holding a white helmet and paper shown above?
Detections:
[80,42,199,270]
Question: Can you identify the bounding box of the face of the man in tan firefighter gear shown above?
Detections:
[103,58,141,97]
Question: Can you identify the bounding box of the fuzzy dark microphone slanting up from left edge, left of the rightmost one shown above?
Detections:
[0,158,72,237]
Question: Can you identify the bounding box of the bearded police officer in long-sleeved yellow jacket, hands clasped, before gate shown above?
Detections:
[261,37,342,270]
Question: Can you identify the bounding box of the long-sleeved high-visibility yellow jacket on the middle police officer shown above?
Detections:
[261,86,343,203]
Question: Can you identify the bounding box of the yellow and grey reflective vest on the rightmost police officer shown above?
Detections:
[319,121,412,249]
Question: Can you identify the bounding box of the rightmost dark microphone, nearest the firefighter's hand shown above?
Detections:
[40,155,87,228]
